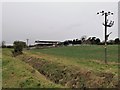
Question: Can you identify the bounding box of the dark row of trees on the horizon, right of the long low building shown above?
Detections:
[60,36,120,46]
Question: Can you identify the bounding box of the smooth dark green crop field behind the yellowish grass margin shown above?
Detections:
[31,45,118,62]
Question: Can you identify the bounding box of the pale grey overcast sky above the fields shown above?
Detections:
[2,2,118,44]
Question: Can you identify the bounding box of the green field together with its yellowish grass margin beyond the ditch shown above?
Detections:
[28,45,118,74]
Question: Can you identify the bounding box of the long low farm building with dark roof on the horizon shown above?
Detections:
[35,41,60,48]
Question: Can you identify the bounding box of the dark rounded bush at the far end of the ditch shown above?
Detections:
[12,41,26,56]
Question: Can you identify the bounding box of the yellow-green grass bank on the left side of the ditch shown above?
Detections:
[2,49,62,88]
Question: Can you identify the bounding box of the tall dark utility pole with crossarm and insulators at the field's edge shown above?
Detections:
[97,11,114,64]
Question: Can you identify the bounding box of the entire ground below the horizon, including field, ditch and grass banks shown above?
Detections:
[2,45,120,88]
